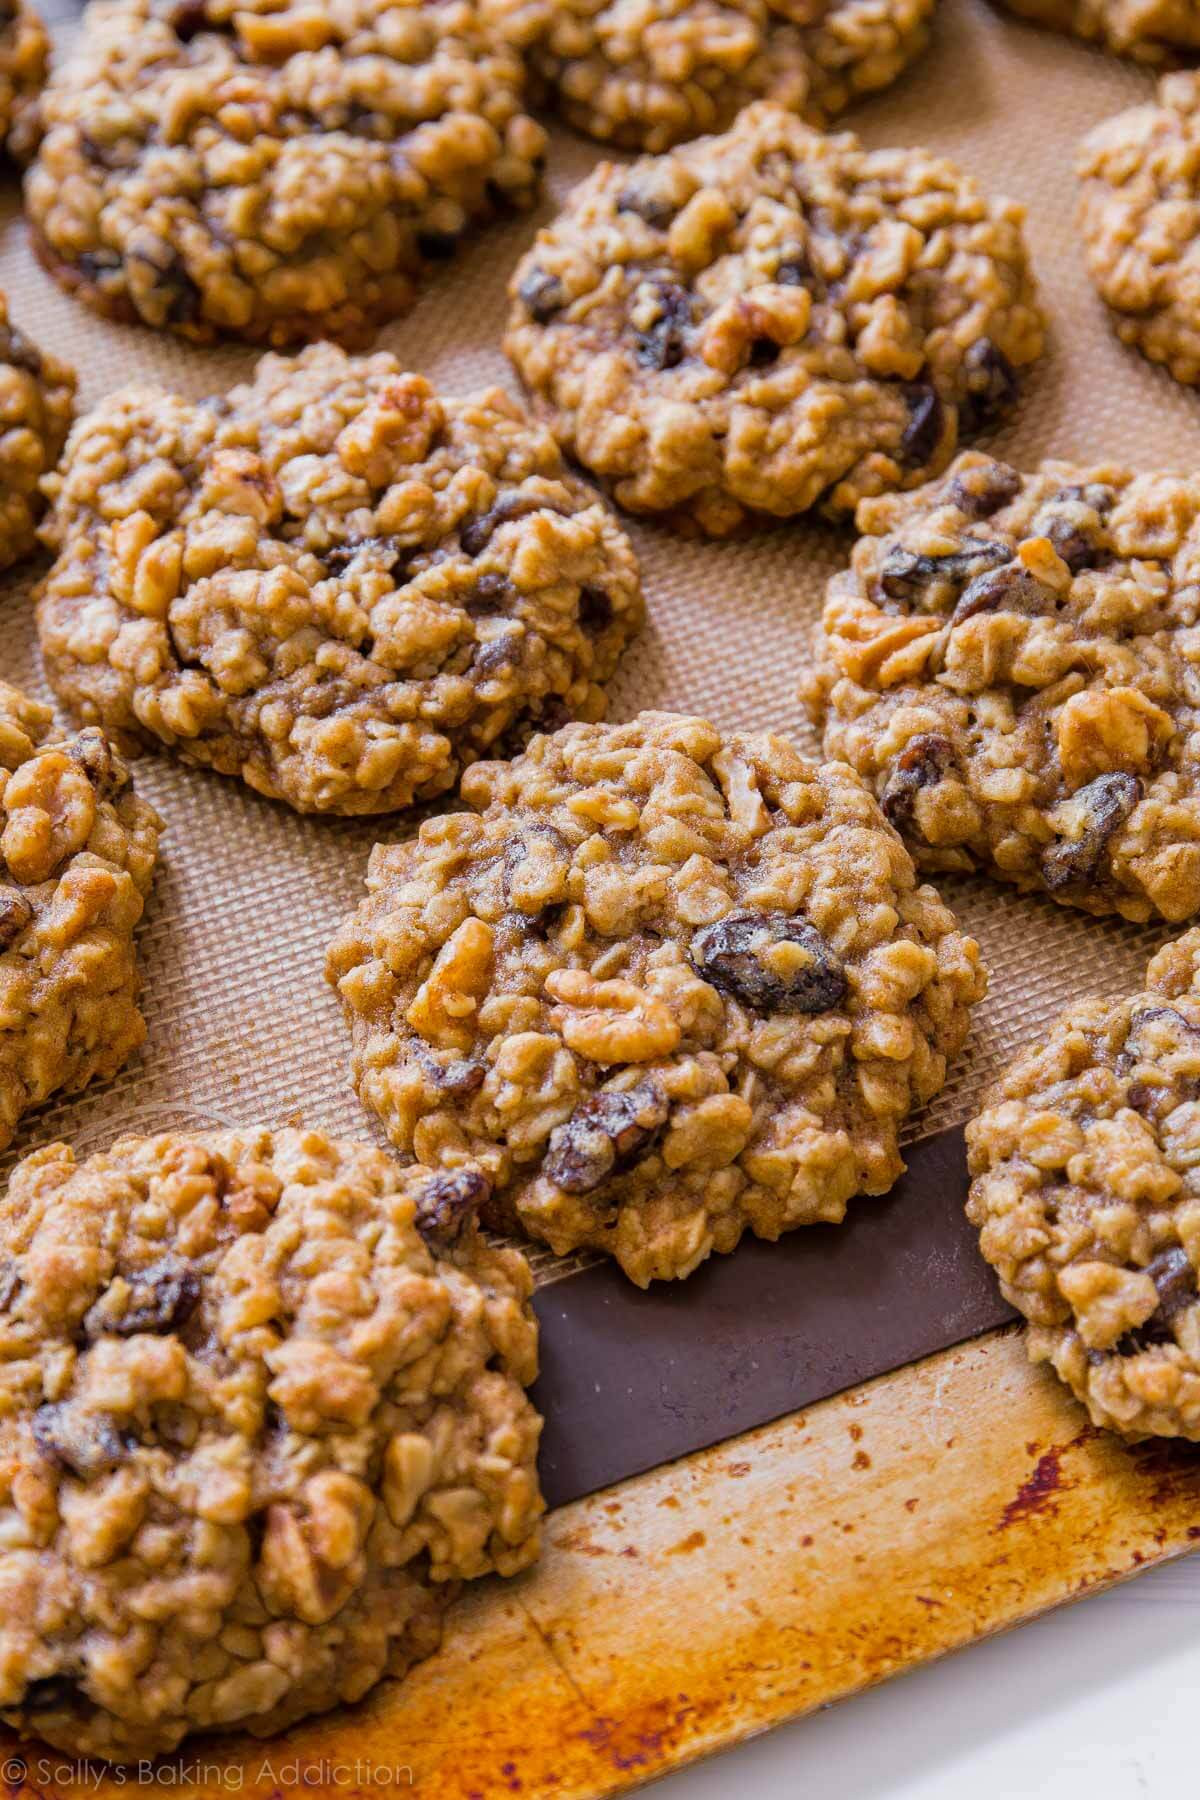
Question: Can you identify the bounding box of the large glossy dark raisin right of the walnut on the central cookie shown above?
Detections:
[691,913,847,1013]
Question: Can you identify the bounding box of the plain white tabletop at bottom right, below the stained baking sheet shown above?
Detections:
[653,1555,1200,1800]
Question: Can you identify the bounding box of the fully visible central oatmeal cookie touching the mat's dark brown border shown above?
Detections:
[327,713,984,1285]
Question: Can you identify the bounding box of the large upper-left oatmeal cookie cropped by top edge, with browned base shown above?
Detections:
[25,0,545,346]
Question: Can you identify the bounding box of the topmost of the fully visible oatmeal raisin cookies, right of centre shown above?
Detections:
[506,103,1042,536]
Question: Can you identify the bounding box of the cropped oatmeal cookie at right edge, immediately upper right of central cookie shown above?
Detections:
[802,454,1200,922]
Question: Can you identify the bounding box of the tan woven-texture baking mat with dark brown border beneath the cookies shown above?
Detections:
[0,0,1200,1501]
